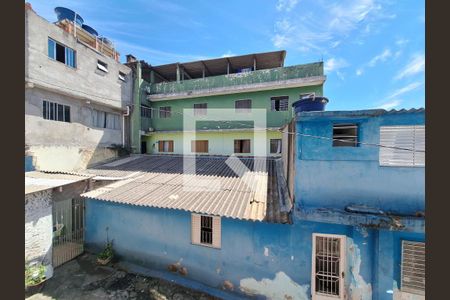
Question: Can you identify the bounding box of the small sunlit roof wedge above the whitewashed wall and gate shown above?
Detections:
[25,171,92,195]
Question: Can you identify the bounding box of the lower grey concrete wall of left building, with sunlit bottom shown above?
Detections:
[25,88,122,171]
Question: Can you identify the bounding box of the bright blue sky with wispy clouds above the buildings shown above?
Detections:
[30,0,425,110]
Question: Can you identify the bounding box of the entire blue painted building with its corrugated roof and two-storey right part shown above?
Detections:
[83,109,425,299]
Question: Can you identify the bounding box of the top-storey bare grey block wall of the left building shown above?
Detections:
[25,9,133,108]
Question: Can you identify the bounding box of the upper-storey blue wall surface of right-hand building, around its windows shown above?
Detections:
[295,112,425,215]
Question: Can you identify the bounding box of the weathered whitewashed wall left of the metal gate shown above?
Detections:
[25,190,53,265]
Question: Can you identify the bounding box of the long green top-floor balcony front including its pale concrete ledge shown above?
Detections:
[146,62,325,101]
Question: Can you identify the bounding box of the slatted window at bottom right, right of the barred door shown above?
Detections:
[401,241,425,295]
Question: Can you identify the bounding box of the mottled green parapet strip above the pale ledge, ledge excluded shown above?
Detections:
[147,62,324,99]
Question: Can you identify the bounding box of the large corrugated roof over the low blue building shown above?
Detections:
[82,155,292,223]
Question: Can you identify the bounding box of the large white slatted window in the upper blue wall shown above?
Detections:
[379,125,425,167]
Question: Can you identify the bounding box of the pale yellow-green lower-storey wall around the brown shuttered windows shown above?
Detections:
[142,131,282,156]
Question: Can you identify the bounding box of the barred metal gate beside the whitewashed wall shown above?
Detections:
[52,198,84,268]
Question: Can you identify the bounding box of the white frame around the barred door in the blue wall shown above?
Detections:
[311,233,347,300]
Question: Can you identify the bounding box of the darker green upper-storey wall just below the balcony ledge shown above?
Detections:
[147,85,323,130]
